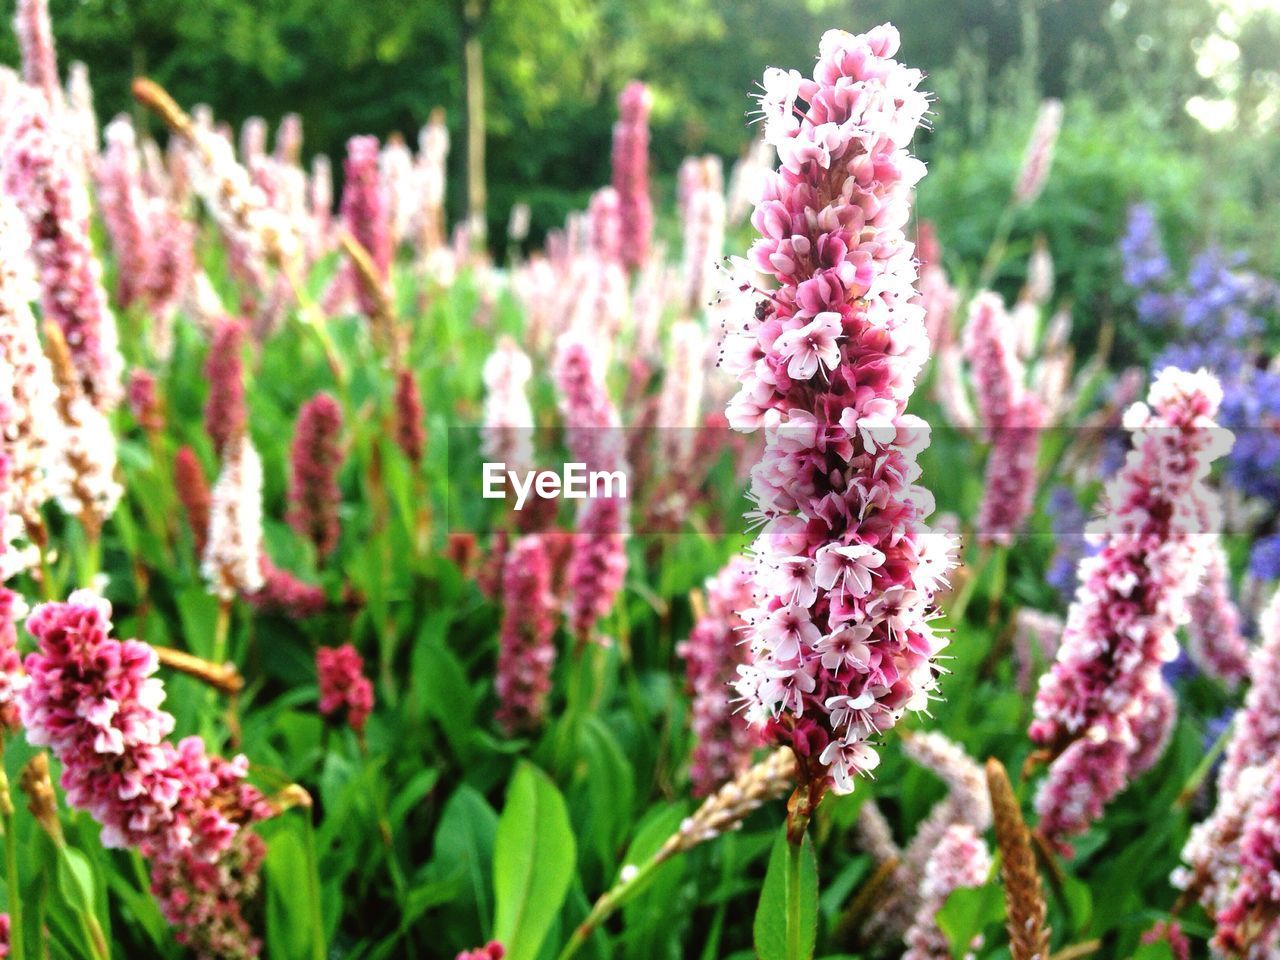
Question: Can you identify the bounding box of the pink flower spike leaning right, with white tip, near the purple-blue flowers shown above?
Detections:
[1029,369,1231,850]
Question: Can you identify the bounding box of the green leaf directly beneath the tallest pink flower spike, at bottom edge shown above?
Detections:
[754,826,818,960]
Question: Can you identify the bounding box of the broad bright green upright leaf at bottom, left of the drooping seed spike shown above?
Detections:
[493,763,577,960]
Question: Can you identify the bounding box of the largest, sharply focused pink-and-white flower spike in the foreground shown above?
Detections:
[726,24,952,800]
